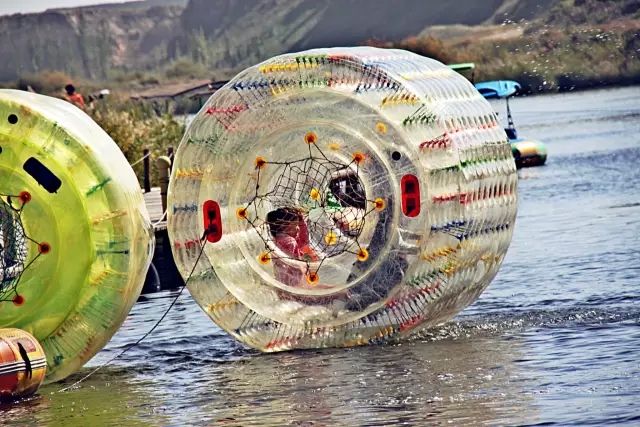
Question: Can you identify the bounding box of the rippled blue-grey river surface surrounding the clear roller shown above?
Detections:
[0,87,640,427]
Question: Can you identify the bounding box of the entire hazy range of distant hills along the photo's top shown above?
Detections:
[0,0,640,81]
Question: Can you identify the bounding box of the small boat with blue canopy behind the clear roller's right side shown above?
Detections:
[449,63,547,169]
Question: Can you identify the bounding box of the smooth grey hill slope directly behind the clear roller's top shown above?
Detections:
[170,0,560,71]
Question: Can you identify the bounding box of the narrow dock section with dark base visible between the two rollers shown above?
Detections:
[142,187,184,294]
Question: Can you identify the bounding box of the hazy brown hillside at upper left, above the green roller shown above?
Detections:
[0,3,184,81]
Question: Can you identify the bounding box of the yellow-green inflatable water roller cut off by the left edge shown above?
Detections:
[0,90,154,382]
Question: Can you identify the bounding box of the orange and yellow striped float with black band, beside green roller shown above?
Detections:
[0,329,47,400]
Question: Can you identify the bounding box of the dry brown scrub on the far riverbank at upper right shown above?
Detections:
[367,20,640,93]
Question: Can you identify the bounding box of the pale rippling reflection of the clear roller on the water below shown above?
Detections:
[148,339,535,425]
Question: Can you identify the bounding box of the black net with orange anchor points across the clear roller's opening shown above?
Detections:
[238,134,384,282]
